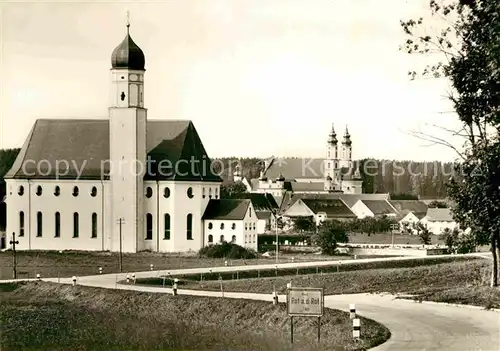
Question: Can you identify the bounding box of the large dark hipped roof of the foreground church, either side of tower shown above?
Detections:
[5,119,222,181]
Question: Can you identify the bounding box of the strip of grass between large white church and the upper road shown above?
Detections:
[0,251,356,279]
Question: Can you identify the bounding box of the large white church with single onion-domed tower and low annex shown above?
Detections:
[5,24,257,252]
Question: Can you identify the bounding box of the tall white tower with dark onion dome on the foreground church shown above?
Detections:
[109,21,147,252]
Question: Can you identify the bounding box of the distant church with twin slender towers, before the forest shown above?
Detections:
[252,125,363,199]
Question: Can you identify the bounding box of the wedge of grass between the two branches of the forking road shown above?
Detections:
[137,257,500,308]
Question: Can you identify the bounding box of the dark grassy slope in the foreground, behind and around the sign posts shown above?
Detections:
[0,283,390,351]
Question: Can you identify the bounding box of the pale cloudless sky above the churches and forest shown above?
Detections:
[0,0,460,161]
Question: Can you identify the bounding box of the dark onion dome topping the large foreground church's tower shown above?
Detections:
[111,23,146,71]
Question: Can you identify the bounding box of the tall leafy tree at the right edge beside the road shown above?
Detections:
[401,0,500,286]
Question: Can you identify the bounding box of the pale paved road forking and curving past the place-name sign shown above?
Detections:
[9,254,500,351]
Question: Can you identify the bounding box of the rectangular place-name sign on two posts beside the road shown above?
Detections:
[286,287,325,344]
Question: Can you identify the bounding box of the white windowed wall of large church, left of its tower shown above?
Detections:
[7,179,107,251]
